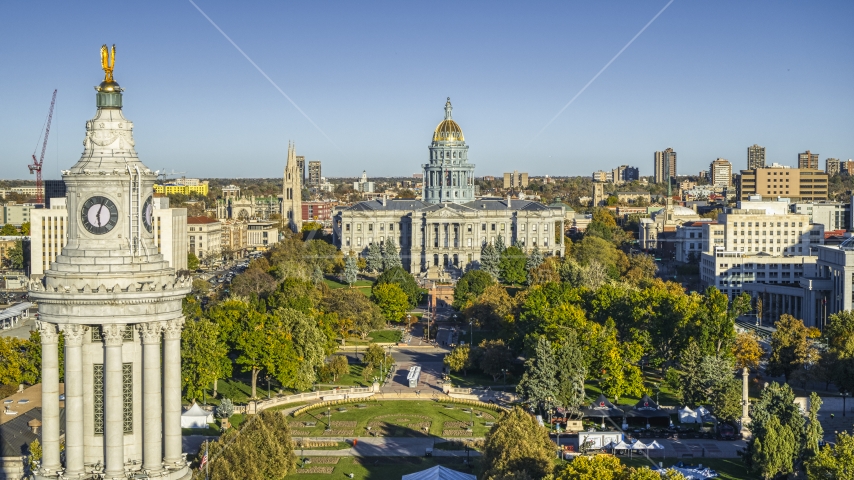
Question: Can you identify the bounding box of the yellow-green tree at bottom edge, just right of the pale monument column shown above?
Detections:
[751,417,798,479]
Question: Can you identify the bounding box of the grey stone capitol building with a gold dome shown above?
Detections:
[333,98,565,278]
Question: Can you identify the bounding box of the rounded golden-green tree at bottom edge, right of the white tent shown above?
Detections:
[481,407,555,480]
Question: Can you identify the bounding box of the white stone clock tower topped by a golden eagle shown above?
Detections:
[30,45,190,479]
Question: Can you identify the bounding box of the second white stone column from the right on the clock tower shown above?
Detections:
[139,322,163,472]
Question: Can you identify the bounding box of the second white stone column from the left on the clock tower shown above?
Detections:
[60,324,89,478]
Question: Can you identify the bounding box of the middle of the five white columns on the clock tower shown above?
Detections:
[102,325,127,478]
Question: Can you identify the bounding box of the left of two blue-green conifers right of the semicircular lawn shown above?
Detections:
[516,336,558,413]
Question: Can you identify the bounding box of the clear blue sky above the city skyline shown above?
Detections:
[0,0,854,178]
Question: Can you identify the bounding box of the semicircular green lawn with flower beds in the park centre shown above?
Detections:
[289,400,499,438]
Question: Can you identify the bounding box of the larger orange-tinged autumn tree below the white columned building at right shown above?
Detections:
[766,314,815,382]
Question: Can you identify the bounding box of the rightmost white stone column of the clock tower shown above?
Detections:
[163,319,184,464]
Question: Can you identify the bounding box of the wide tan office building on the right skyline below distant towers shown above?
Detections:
[736,164,828,202]
